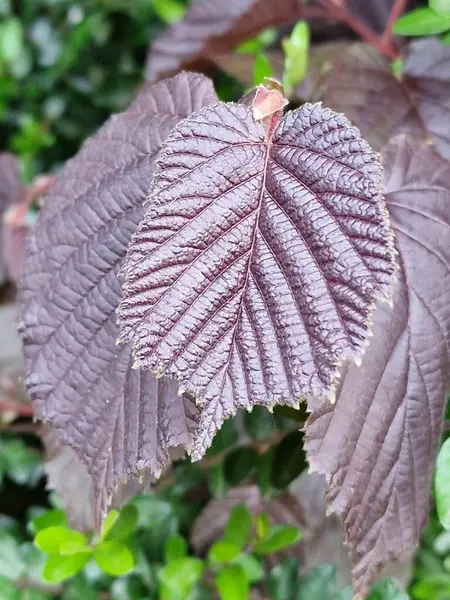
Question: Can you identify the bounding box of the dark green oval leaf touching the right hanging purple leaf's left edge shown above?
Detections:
[270,431,308,490]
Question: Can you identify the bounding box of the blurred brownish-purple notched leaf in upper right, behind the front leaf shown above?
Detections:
[324,39,450,158]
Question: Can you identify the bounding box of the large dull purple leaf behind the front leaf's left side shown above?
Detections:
[21,74,215,525]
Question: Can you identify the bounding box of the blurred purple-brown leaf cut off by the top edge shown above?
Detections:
[146,0,302,81]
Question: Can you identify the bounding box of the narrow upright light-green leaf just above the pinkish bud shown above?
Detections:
[282,21,310,94]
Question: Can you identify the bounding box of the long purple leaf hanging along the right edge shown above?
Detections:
[307,137,450,598]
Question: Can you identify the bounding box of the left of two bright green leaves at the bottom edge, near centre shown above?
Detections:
[159,557,204,600]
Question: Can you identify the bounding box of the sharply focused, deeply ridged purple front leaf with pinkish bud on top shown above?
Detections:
[119,95,394,459]
